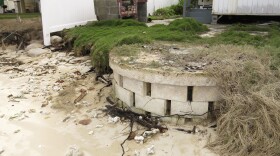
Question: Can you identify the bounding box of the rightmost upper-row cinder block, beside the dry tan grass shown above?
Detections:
[193,86,219,102]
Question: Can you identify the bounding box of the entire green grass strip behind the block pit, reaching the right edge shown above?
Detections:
[65,18,280,73]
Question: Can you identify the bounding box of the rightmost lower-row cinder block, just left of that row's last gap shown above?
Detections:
[191,102,209,118]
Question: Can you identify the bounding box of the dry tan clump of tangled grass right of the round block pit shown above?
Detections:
[190,45,280,156]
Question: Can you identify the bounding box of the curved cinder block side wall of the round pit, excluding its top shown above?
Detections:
[111,63,219,119]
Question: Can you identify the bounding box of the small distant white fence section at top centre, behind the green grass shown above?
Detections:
[147,0,179,15]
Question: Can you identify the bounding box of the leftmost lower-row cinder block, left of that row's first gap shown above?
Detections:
[115,84,134,107]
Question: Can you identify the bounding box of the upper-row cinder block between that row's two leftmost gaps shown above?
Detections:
[123,77,147,96]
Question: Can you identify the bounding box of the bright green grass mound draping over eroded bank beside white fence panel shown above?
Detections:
[65,18,208,73]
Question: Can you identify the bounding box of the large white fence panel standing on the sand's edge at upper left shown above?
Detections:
[41,0,97,46]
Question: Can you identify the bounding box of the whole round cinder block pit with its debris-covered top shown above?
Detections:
[110,45,219,123]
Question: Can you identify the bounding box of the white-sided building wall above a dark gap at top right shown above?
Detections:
[213,0,280,16]
